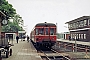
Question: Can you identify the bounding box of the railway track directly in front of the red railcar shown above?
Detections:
[38,46,71,60]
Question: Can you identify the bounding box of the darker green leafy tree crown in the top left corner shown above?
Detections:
[0,0,16,20]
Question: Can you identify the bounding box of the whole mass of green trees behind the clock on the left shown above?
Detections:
[0,0,23,32]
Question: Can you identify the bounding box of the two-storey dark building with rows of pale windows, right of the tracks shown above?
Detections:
[66,16,90,42]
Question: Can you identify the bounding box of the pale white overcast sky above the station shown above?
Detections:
[7,0,90,34]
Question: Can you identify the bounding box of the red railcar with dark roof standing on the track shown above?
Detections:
[30,22,57,47]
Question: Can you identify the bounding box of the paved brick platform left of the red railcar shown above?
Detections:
[2,40,42,60]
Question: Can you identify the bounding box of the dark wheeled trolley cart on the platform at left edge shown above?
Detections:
[0,37,12,58]
